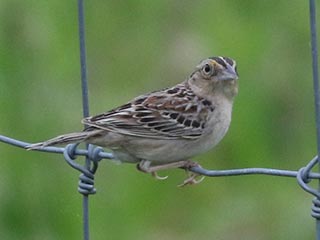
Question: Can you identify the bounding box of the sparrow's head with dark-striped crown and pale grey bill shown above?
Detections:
[188,57,238,99]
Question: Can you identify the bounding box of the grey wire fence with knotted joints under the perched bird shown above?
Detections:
[0,0,320,240]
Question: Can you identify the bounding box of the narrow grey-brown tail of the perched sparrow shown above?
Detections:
[26,130,101,150]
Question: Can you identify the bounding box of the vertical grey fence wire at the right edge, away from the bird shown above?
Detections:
[309,0,320,240]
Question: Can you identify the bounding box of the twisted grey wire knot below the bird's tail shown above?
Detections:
[63,144,103,195]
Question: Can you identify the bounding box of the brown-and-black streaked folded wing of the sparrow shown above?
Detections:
[83,84,214,139]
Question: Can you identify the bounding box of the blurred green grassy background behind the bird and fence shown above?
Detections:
[0,0,320,240]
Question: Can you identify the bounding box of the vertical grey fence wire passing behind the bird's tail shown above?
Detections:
[78,0,90,240]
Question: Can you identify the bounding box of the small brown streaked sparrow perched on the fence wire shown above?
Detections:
[27,57,238,185]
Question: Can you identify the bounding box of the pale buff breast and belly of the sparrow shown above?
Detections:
[104,98,232,165]
